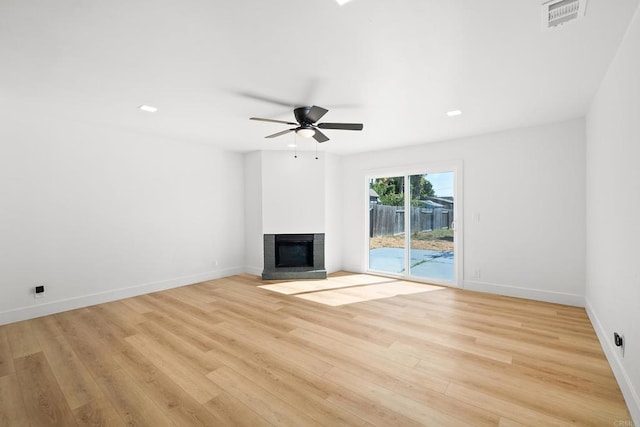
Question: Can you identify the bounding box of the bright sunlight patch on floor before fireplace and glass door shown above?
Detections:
[259,274,444,306]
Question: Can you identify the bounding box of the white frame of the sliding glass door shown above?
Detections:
[362,160,464,288]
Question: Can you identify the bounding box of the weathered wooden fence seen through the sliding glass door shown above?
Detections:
[369,204,453,237]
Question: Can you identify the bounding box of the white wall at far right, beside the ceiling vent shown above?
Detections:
[586,4,640,425]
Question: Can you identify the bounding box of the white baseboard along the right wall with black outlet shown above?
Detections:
[585,300,640,426]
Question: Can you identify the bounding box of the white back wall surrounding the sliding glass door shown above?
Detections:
[343,120,585,305]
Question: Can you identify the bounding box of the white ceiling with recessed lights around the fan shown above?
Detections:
[0,0,639,154]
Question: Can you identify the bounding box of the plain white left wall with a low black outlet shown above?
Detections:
[0,113,244,323]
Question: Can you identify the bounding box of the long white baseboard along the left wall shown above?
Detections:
[0,267,244,325]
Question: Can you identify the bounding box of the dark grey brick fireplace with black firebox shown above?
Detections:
[262,234,327,280]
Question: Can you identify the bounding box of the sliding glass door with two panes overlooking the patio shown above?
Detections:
[368,168,461,285]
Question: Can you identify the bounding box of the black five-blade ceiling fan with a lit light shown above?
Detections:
[250,105,363,142]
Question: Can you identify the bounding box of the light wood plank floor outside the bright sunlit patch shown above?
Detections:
[0,273,630,426]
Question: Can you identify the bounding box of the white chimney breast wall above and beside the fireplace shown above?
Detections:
[244,150,342,275]
